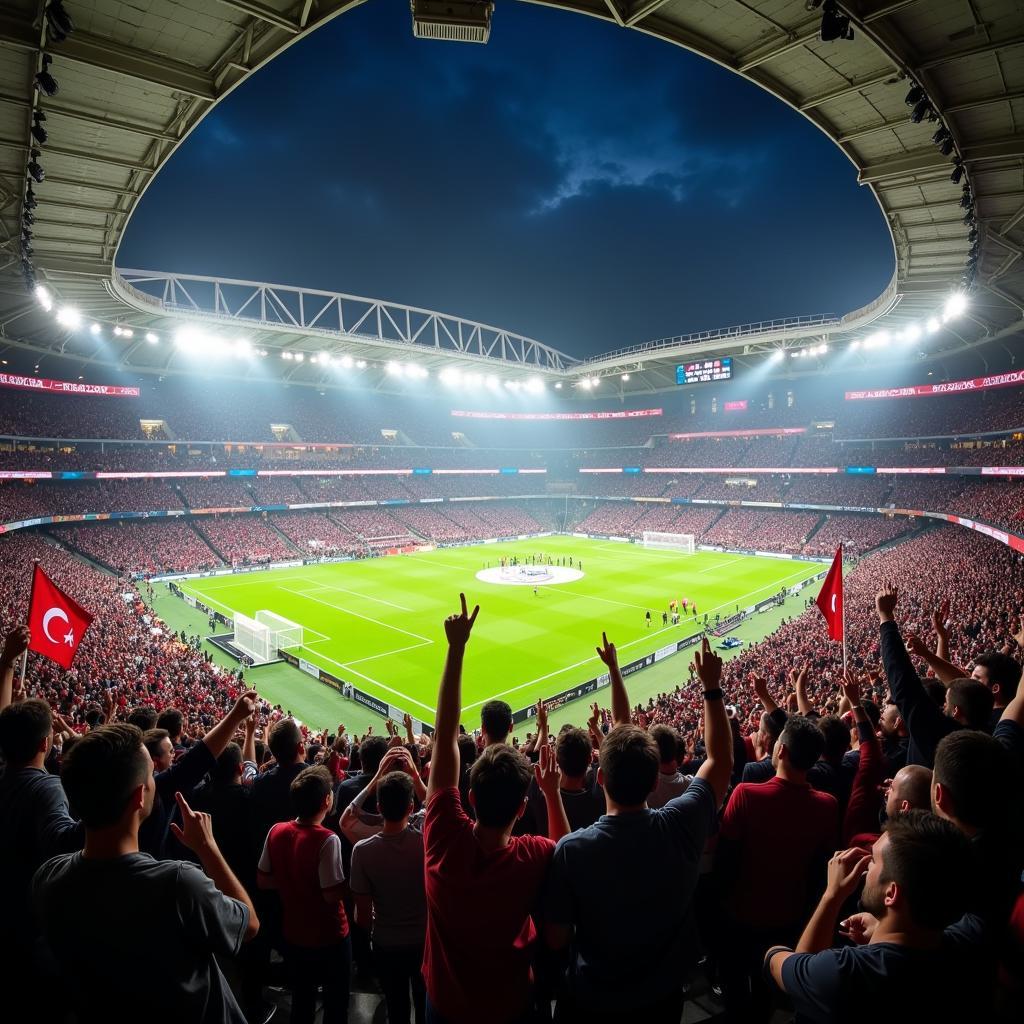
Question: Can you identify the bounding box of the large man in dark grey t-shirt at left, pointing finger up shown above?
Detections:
[32,724,259,1024]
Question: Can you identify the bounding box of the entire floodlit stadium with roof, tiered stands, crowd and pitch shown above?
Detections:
[0,6,1024,1024]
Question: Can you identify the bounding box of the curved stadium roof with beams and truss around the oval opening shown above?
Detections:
[0,0,1024,391]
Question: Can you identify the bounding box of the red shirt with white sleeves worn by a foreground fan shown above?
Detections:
[259,821,348,948]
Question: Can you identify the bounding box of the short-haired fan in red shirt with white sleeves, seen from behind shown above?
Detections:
[257,765,351,1024]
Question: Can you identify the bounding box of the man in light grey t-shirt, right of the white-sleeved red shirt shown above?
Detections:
[351,761,427,1024]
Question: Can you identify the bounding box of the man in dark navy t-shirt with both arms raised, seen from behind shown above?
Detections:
[546,637,732,1024]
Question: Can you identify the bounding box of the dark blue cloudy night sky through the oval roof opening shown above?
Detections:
[118,0,893,356]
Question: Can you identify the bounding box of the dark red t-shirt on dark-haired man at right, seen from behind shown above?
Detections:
[719,775,839,928]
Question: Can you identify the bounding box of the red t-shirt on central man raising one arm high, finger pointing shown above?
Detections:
[423,787,555,1024]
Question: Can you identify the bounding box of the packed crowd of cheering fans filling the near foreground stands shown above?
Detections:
[0,528,1024,1024]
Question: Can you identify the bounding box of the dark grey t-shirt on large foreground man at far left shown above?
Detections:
[32,853,249,1024]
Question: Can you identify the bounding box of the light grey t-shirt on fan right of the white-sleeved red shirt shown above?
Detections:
[350,827,427,948]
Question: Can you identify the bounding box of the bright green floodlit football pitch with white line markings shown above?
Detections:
[179,537,822,723]
